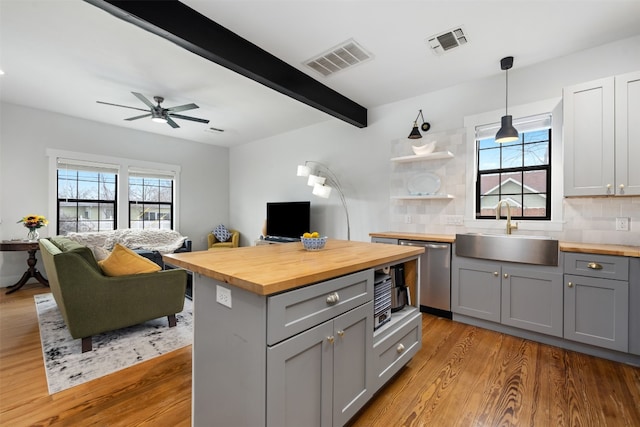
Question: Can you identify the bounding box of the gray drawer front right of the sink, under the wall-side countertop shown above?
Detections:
[564,253,629,280]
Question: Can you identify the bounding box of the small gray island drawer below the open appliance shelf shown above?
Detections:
[373,311,422,388]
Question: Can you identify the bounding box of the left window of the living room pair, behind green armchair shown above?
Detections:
[57,159,118,235]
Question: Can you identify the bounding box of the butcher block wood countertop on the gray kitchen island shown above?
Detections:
[163,239,424,295]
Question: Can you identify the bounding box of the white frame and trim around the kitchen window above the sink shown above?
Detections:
[464,98,564,232]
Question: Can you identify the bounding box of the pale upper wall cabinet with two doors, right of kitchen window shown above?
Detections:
[563,71,640,196]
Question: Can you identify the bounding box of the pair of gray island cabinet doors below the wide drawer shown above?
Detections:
[267,302,374,427]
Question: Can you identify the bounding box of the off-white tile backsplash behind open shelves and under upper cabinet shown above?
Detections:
[389,129,640,246]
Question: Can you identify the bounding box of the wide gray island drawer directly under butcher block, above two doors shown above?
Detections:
[267,269,373,345]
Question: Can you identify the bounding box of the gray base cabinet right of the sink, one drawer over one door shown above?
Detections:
[564,253,629,352]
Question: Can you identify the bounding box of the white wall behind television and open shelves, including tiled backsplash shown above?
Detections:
[230,37,640,245]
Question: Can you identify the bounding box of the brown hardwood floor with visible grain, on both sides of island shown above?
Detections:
[0,284,640,427]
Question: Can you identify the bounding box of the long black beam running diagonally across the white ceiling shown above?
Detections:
[85,0,367,128]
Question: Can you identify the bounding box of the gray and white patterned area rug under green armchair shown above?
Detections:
[34,293,193,394]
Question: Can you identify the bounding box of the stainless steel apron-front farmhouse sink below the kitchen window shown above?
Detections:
[456,233,558,266]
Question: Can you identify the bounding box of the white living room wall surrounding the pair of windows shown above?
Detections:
[0,104,229,286]
